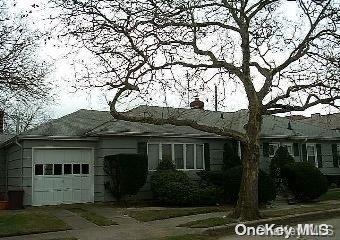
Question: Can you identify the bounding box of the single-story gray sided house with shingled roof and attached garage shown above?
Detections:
[0,106,340,206]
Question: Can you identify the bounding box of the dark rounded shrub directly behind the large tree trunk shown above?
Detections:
[224,166,276,203]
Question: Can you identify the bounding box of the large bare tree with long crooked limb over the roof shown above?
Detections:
[52,0,340,219]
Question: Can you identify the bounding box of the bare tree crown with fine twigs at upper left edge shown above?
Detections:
[0,1,49,99]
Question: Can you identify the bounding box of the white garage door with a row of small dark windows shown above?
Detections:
[32,148,94,206]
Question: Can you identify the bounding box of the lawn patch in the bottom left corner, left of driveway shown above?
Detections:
[0,211,70,237]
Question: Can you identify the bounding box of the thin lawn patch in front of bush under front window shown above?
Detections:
[128,207,226,222]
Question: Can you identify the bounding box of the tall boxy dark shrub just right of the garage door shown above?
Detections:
[104,154,148,201]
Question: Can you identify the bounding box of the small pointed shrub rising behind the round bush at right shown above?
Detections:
[270,146,295,178]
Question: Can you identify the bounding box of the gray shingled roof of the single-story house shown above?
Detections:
[23,105,340,138]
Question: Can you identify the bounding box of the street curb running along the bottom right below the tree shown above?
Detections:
[203,208,340,236]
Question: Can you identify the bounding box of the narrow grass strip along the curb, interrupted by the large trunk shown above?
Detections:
[178,204,340,228]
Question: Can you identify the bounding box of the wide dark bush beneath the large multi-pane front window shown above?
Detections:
[151,160,219,206]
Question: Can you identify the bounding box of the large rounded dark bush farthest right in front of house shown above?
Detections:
[282,162,328,201]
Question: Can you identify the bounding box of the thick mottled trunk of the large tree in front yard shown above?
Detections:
[232,108,262,220]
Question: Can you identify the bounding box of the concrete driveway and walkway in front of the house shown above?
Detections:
[1,207,226,240]
